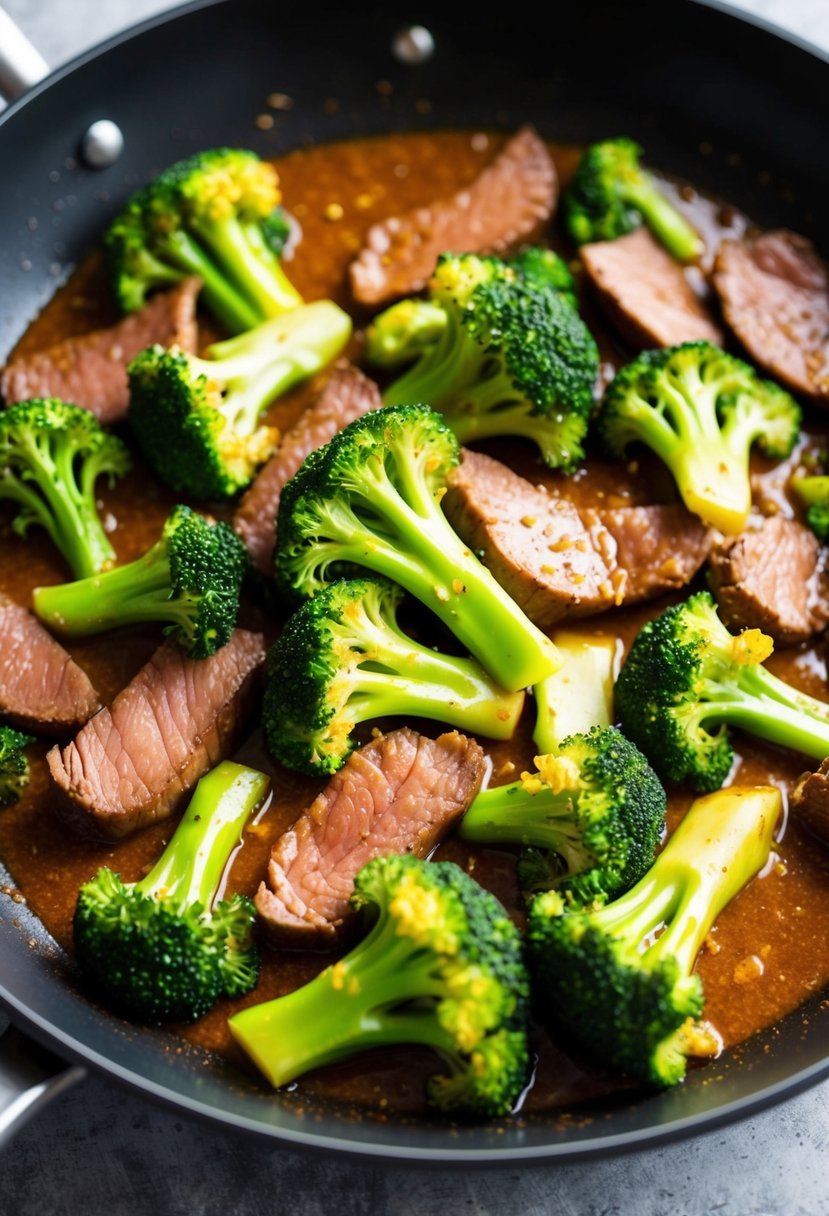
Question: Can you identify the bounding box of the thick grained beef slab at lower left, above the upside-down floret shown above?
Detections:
[46,629,265,839]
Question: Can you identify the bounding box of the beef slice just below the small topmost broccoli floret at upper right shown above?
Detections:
[579,227,723,349]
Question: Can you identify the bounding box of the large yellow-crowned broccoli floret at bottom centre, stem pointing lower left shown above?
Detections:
[229,857,529,1118]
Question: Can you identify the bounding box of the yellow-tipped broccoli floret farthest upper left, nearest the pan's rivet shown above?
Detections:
[105,148,301,333]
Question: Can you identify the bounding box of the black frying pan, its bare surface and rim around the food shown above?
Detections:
[0,0,829,1164]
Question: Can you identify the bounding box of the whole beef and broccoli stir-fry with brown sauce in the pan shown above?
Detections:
[0,126,829,1121]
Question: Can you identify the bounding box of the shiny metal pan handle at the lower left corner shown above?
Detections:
[0,1014,86,1148]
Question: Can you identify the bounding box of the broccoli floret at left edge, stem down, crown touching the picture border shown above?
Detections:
[0,396,130,579]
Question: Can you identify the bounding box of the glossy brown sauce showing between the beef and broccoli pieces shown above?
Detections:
[0,133,829,1113]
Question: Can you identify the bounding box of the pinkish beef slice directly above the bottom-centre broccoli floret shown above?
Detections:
[256,727,484,946]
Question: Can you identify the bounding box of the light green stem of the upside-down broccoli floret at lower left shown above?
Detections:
[135,760,269,910]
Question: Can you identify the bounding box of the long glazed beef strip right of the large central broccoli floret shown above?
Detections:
[444,451,711,629]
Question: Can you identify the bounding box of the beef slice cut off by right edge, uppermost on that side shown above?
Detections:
[714,230,829,401]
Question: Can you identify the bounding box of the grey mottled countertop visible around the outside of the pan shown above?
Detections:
[0,0,829,1216]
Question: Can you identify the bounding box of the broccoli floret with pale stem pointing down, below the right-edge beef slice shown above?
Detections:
[597,342,800,535]
